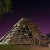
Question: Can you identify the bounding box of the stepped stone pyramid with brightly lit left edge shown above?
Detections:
[0,18,50,46]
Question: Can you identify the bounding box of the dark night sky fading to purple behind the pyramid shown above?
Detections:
[0,0,50,37]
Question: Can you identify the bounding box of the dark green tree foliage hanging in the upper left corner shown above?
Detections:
[0,0,12,15]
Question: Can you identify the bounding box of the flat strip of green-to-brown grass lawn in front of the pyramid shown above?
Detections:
[0,45,50,50]
